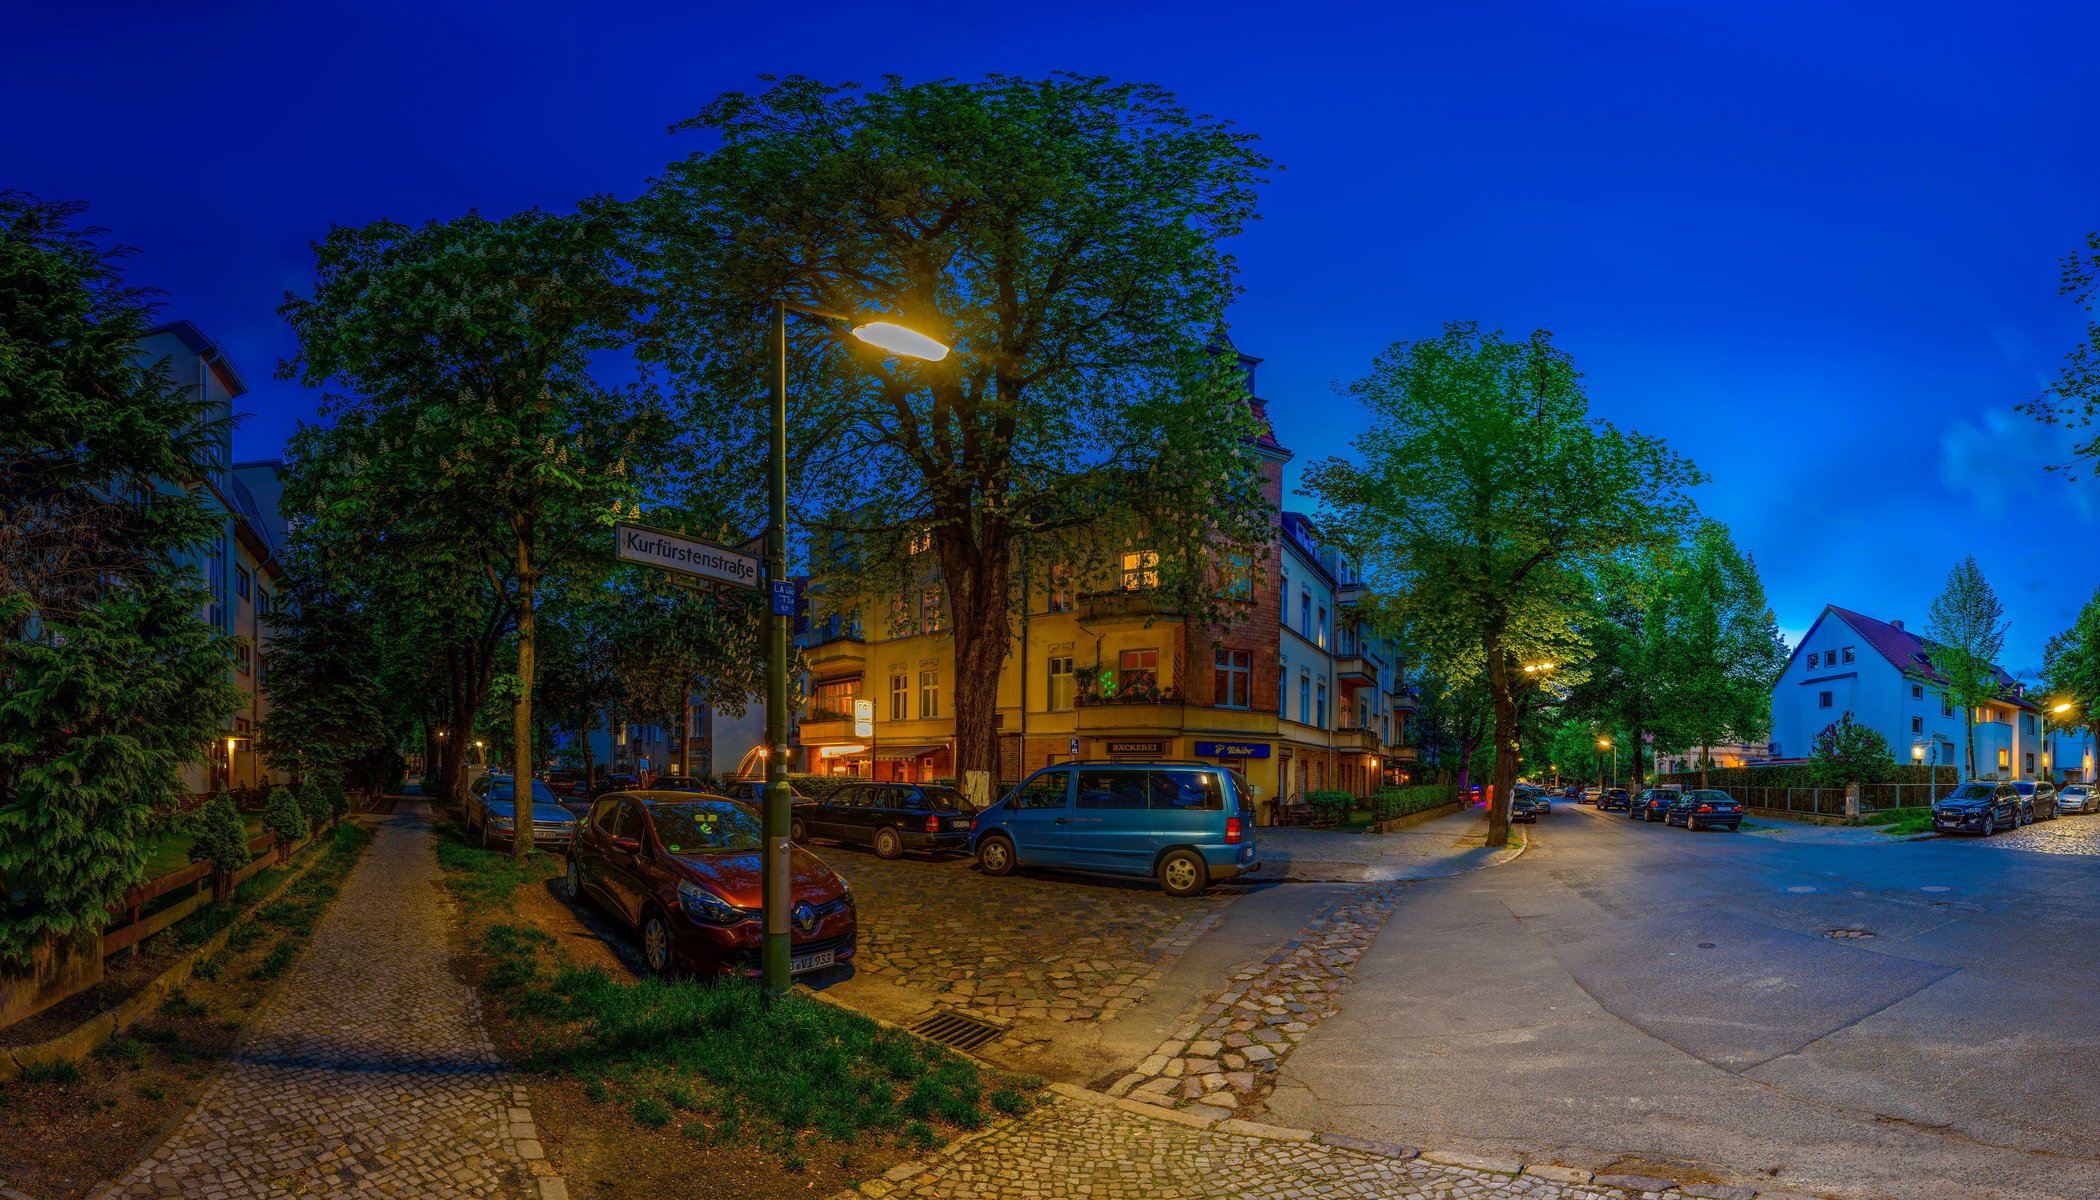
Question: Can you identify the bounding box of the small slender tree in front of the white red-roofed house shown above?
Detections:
[1661,521,1787,788]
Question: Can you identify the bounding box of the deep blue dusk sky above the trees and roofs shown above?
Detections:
[0,0,2100,670]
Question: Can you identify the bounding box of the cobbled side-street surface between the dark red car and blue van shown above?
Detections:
[813,843,1235,1021]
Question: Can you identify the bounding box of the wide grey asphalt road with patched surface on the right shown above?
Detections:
[1271,805,2100,1200]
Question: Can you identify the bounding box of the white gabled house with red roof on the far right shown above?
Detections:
[1772,605,2094,782]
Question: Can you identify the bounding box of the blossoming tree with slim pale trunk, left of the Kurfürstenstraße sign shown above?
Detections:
[281,202,664,855]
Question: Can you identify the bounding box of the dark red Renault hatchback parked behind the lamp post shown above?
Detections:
[563,790,859,975]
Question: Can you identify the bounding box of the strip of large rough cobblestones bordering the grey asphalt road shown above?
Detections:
[1109,883,1407,1118]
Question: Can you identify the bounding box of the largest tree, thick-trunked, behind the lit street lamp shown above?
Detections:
[643,76,1268,798]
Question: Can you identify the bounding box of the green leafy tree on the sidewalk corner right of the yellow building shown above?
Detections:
[1306,322,1699,845]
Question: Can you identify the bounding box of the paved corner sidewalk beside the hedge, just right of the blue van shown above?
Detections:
[1245,809,1528,883]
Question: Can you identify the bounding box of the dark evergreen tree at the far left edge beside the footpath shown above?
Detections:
[0,193,237,963]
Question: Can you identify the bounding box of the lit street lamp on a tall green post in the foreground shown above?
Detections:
[758,296,947,996]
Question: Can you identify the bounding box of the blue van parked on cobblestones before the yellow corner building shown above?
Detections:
[970,763,1262,895]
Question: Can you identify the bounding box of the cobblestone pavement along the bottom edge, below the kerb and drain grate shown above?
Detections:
[846,1089,1783,1200]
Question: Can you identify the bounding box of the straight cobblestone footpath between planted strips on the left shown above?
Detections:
[101,801,565,1200]
